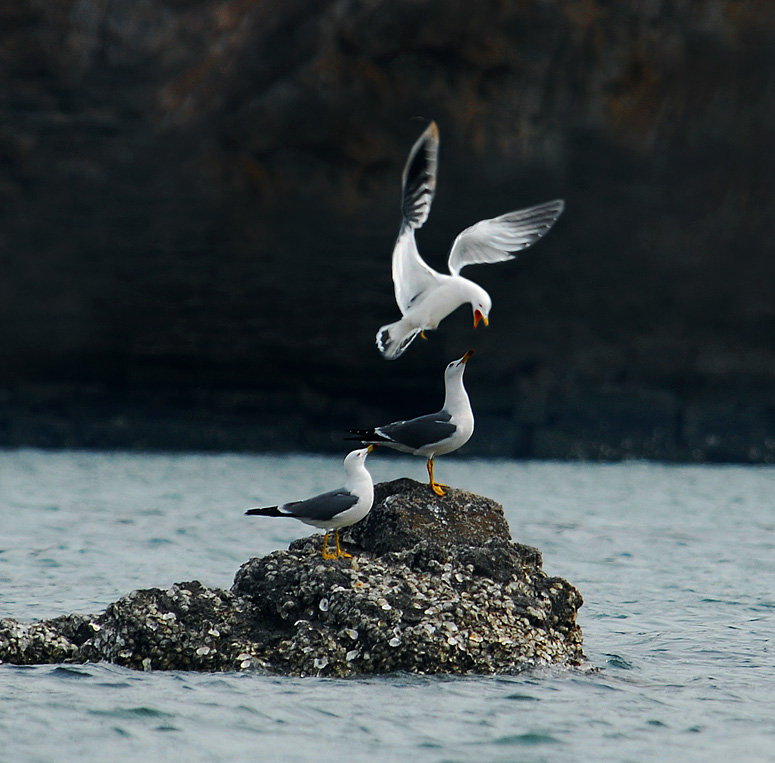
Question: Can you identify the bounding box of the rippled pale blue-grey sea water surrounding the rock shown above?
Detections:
[0,450,775,763]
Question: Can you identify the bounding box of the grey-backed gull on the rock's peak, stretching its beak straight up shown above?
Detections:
[347,350,474,495]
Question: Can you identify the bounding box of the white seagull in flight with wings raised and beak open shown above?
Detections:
[377,122,565,360]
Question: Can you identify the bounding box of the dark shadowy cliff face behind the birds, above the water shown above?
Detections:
[0,0,775,460]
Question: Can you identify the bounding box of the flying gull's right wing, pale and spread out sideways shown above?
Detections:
[449,199,565,275]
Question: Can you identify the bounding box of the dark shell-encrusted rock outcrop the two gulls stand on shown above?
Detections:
[0,480,584,676]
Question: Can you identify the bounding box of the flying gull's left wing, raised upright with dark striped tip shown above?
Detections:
[393,122,440,315]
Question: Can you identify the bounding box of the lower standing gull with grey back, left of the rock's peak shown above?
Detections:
[245,445,374,559]
